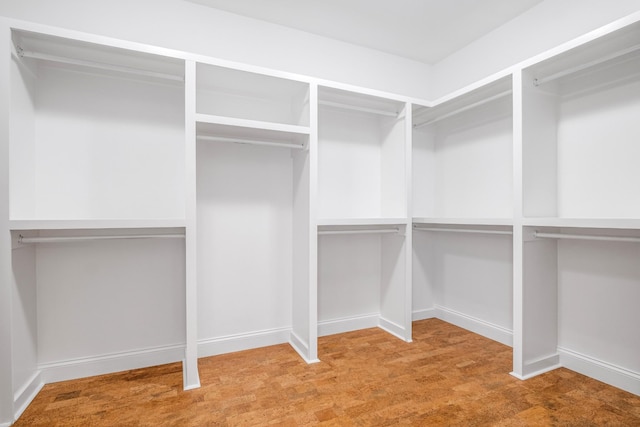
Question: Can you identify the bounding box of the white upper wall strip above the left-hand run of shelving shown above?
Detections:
[0,0,430,97]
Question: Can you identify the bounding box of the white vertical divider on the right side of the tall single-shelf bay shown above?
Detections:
[290,84,319,363]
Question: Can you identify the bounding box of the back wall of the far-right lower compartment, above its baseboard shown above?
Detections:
[558,240,640,378]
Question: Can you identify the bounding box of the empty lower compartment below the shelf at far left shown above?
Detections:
[9,224,185,405]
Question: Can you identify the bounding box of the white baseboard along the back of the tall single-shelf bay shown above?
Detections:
[198,328,291,357]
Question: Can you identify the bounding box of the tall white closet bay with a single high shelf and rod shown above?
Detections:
[194,63,316,361]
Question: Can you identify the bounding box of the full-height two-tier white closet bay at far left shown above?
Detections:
[2,24,196,413]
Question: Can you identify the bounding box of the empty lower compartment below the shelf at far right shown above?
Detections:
[523,226,640,394]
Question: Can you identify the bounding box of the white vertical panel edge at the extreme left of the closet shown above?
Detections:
[0,19,14,426]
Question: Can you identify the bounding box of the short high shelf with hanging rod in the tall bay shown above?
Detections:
[196,114,311,149]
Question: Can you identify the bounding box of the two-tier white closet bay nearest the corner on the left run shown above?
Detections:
[317,86,411,341]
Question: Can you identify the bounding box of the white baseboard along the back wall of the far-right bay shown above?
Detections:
[558,347,640,396]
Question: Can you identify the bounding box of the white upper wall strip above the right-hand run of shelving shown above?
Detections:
[430,0,640,98]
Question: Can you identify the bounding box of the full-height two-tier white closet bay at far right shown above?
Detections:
[514,18,640,394]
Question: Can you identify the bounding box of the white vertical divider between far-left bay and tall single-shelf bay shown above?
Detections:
[182,61,200,390]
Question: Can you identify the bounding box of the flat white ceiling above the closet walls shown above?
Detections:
[189,0,543,64]
